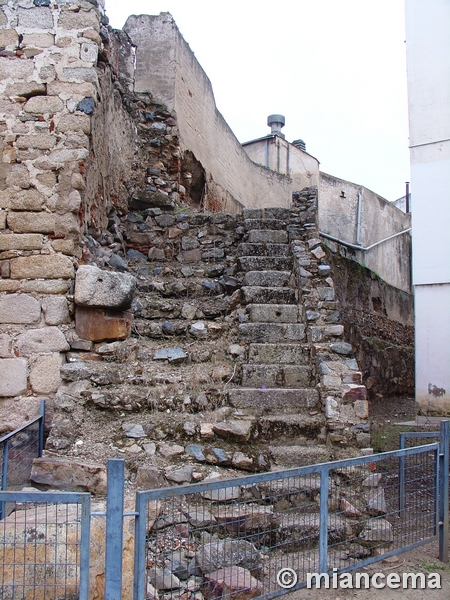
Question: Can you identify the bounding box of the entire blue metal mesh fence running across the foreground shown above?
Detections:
[0,421,450,600]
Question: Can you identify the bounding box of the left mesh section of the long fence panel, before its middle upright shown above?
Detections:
[137,473,320,600]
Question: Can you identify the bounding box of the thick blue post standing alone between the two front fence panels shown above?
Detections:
[104,458,124,600]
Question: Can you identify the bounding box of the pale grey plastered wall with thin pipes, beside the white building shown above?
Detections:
[319,173,411,293]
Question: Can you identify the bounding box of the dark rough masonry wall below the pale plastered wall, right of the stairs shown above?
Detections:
[327,242,414,400]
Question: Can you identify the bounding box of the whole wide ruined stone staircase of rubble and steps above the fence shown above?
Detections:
[46,189,368,487]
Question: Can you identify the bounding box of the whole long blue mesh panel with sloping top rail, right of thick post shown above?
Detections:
[135,444,438,600]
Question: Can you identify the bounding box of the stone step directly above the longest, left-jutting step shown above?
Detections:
[242,364,311,388]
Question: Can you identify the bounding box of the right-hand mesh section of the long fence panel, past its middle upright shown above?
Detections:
[328,447,437,571]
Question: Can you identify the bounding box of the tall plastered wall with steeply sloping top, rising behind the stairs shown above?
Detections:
[124,13,291,212]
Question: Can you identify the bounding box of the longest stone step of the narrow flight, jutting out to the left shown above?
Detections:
[228,387,320,415]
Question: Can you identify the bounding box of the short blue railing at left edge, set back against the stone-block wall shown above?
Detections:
[0,400,45,519]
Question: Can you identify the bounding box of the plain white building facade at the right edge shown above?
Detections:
[405,0,450,414]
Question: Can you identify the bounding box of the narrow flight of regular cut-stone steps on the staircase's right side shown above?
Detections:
[228,208,330,467]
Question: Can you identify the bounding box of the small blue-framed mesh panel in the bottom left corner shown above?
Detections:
[0,492,90,600]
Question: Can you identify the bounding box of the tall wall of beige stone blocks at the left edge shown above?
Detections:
[0,0,108,431]
